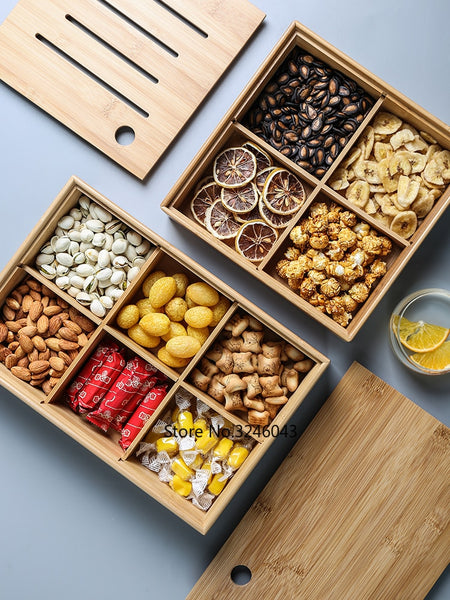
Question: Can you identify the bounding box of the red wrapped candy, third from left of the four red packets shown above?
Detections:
[87,356,155,433]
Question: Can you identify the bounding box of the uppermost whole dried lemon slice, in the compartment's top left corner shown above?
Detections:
[213,148,256,188]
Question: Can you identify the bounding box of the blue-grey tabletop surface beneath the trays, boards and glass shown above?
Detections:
[0,0,450,600]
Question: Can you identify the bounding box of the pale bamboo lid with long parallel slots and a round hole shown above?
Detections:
[0,0,265,179]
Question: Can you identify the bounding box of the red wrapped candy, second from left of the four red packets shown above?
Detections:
[78,351,125,413]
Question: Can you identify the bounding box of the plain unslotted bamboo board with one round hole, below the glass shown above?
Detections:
[188,363,450,600]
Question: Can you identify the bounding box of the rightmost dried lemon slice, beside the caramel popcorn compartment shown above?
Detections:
[262,168,305,215]
